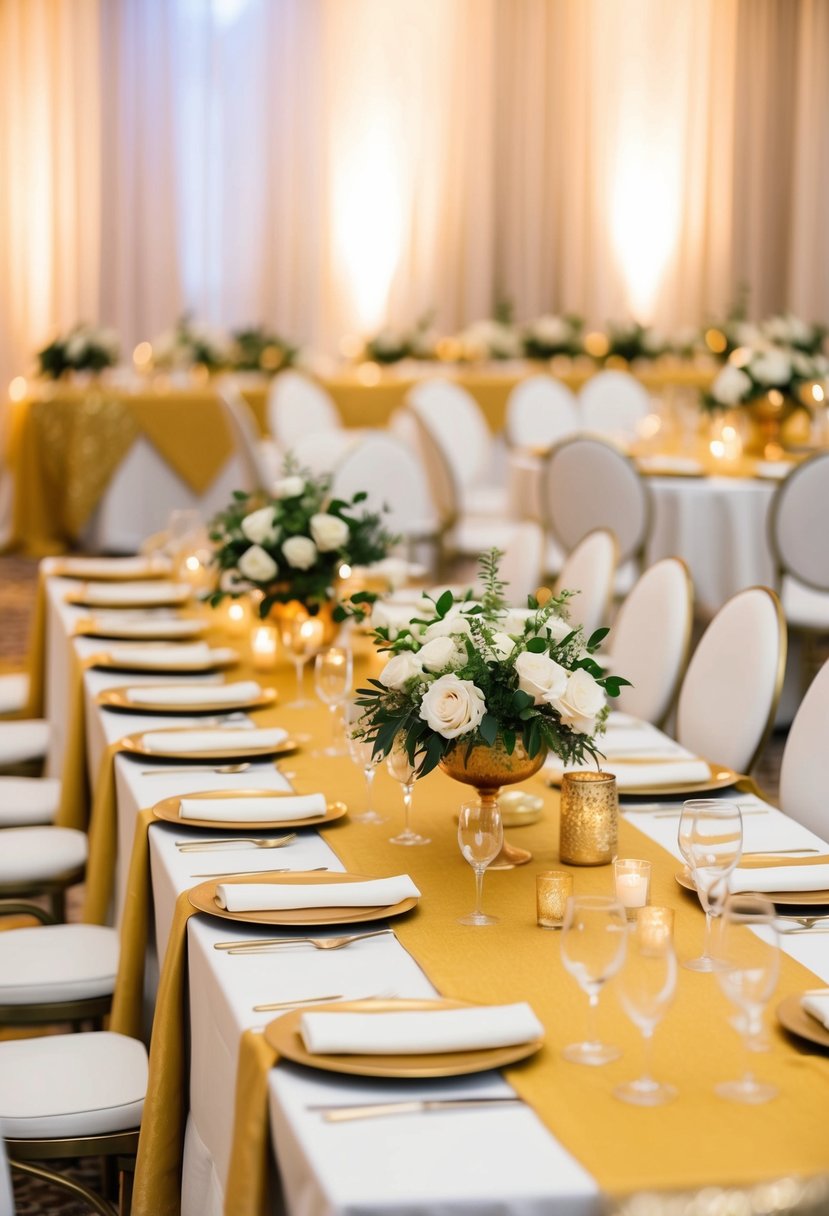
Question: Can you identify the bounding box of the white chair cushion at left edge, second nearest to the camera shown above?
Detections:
[0,924,118,1004]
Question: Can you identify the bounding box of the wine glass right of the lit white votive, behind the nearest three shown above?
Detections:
[678,798,743,972]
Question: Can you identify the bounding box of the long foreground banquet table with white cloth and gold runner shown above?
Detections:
[38,578,829,1216]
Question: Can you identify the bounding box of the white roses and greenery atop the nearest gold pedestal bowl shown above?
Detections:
[347,550,628,783]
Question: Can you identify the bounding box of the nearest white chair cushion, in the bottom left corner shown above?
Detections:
[0,1026,147,1139]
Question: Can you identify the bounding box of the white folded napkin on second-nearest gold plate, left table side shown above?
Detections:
[216,874,421,912]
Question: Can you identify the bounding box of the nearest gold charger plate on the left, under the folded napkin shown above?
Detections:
[265,998,543,1080]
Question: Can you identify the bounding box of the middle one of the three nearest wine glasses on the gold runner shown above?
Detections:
[613,907,677,1107]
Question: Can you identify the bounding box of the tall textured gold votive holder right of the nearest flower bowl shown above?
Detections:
[559,771,619,866]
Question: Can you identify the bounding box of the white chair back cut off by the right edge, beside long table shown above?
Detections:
[780,662,829,839]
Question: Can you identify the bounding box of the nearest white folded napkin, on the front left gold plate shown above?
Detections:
[299,1002,543,1055]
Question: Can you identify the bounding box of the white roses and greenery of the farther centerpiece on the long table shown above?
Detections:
[210,460,395,619]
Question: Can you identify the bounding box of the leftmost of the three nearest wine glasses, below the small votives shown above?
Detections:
[562,895,627,1064]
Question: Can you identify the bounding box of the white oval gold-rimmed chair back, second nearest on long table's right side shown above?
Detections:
[676,587,786,773]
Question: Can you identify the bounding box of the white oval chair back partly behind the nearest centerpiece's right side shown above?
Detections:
[602,557,694,726]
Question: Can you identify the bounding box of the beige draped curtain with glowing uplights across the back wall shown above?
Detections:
[0,0,829,382]
